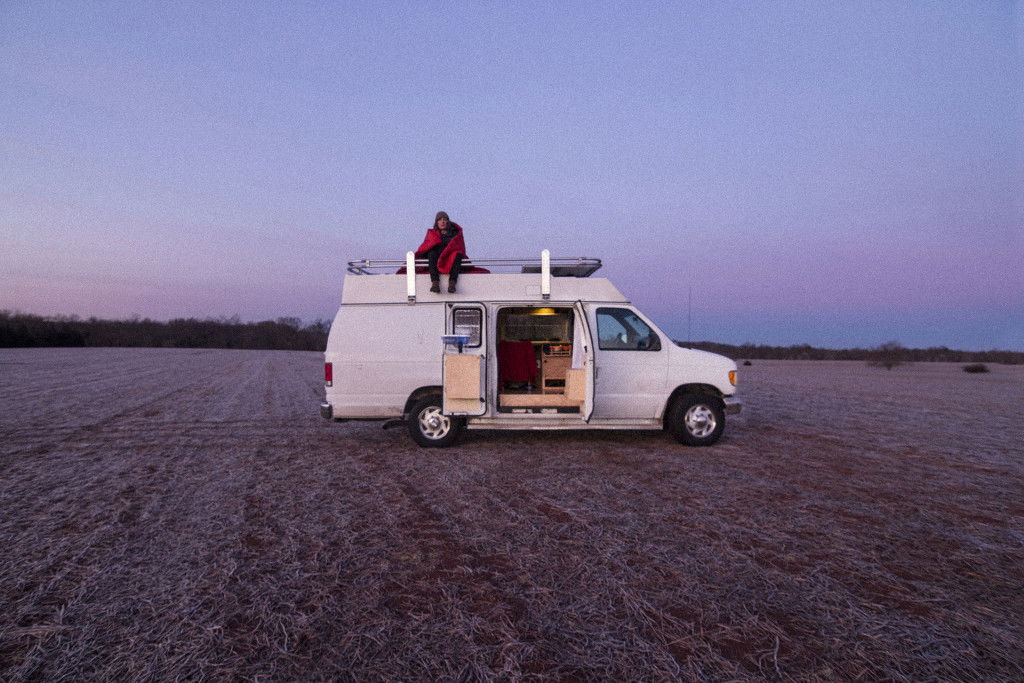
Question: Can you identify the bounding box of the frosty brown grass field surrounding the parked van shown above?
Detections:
[0,349,1024,681]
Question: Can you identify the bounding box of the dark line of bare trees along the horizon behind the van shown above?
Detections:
[0,310,1024,365]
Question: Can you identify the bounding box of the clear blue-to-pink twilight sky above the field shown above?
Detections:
[0,0,1024,350]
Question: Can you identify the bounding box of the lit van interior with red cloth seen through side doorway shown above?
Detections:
[498,306,583,413]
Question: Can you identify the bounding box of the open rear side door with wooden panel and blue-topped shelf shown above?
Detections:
[441,303,487,417]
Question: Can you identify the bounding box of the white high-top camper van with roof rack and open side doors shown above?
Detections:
[321,251,740,446]
